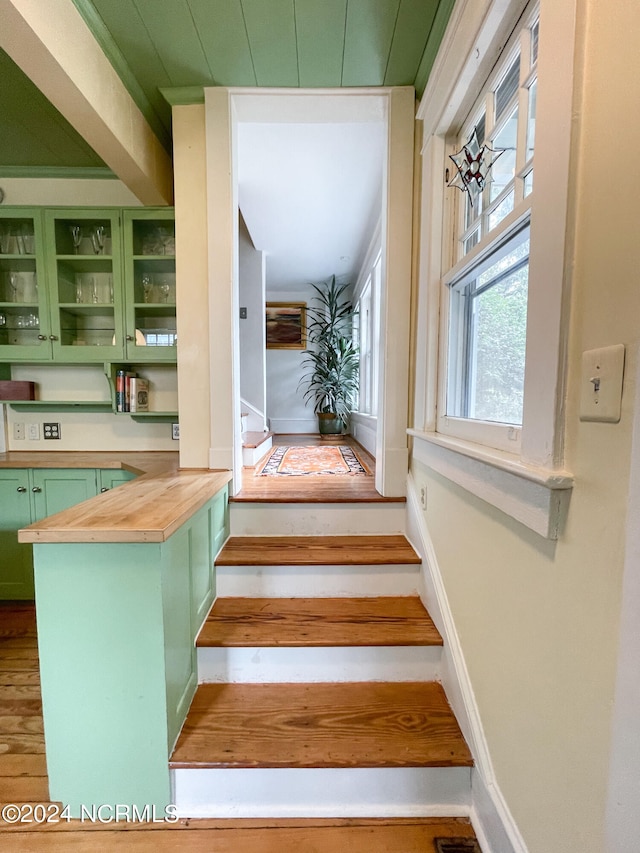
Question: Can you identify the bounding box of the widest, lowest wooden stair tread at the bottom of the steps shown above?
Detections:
[170,682,473,768]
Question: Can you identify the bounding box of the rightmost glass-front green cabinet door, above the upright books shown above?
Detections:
[124,208,177,361]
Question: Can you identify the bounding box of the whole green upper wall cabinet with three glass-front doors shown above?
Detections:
[0,208,176,364]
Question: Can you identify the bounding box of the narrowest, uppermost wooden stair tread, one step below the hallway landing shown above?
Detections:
[216,534,420,566]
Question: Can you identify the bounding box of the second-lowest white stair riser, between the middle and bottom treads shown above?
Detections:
[197,646,442,684]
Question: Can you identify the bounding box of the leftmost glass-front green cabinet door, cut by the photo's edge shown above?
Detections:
[0,208,52,361]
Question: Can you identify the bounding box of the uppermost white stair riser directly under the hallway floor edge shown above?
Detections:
[229,501,405,536]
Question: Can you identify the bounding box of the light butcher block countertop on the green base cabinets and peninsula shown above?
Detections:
[0,451,231,542]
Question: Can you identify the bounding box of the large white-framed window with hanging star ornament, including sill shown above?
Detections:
[409,0,579,539]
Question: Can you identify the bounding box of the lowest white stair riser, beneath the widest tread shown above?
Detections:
[171,764,471,818]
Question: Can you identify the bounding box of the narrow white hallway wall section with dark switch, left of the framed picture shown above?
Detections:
[238,214,267,431]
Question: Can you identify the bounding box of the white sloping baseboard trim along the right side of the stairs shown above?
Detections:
[407,474,527,853]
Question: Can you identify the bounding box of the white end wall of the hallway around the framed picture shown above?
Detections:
[267,290,318,433]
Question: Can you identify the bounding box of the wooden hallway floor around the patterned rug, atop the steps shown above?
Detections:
[232,435,405,503]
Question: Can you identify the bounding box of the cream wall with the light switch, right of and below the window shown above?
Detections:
[412,0,640,853]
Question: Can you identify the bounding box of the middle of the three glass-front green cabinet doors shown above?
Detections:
[45,208,125,362]
